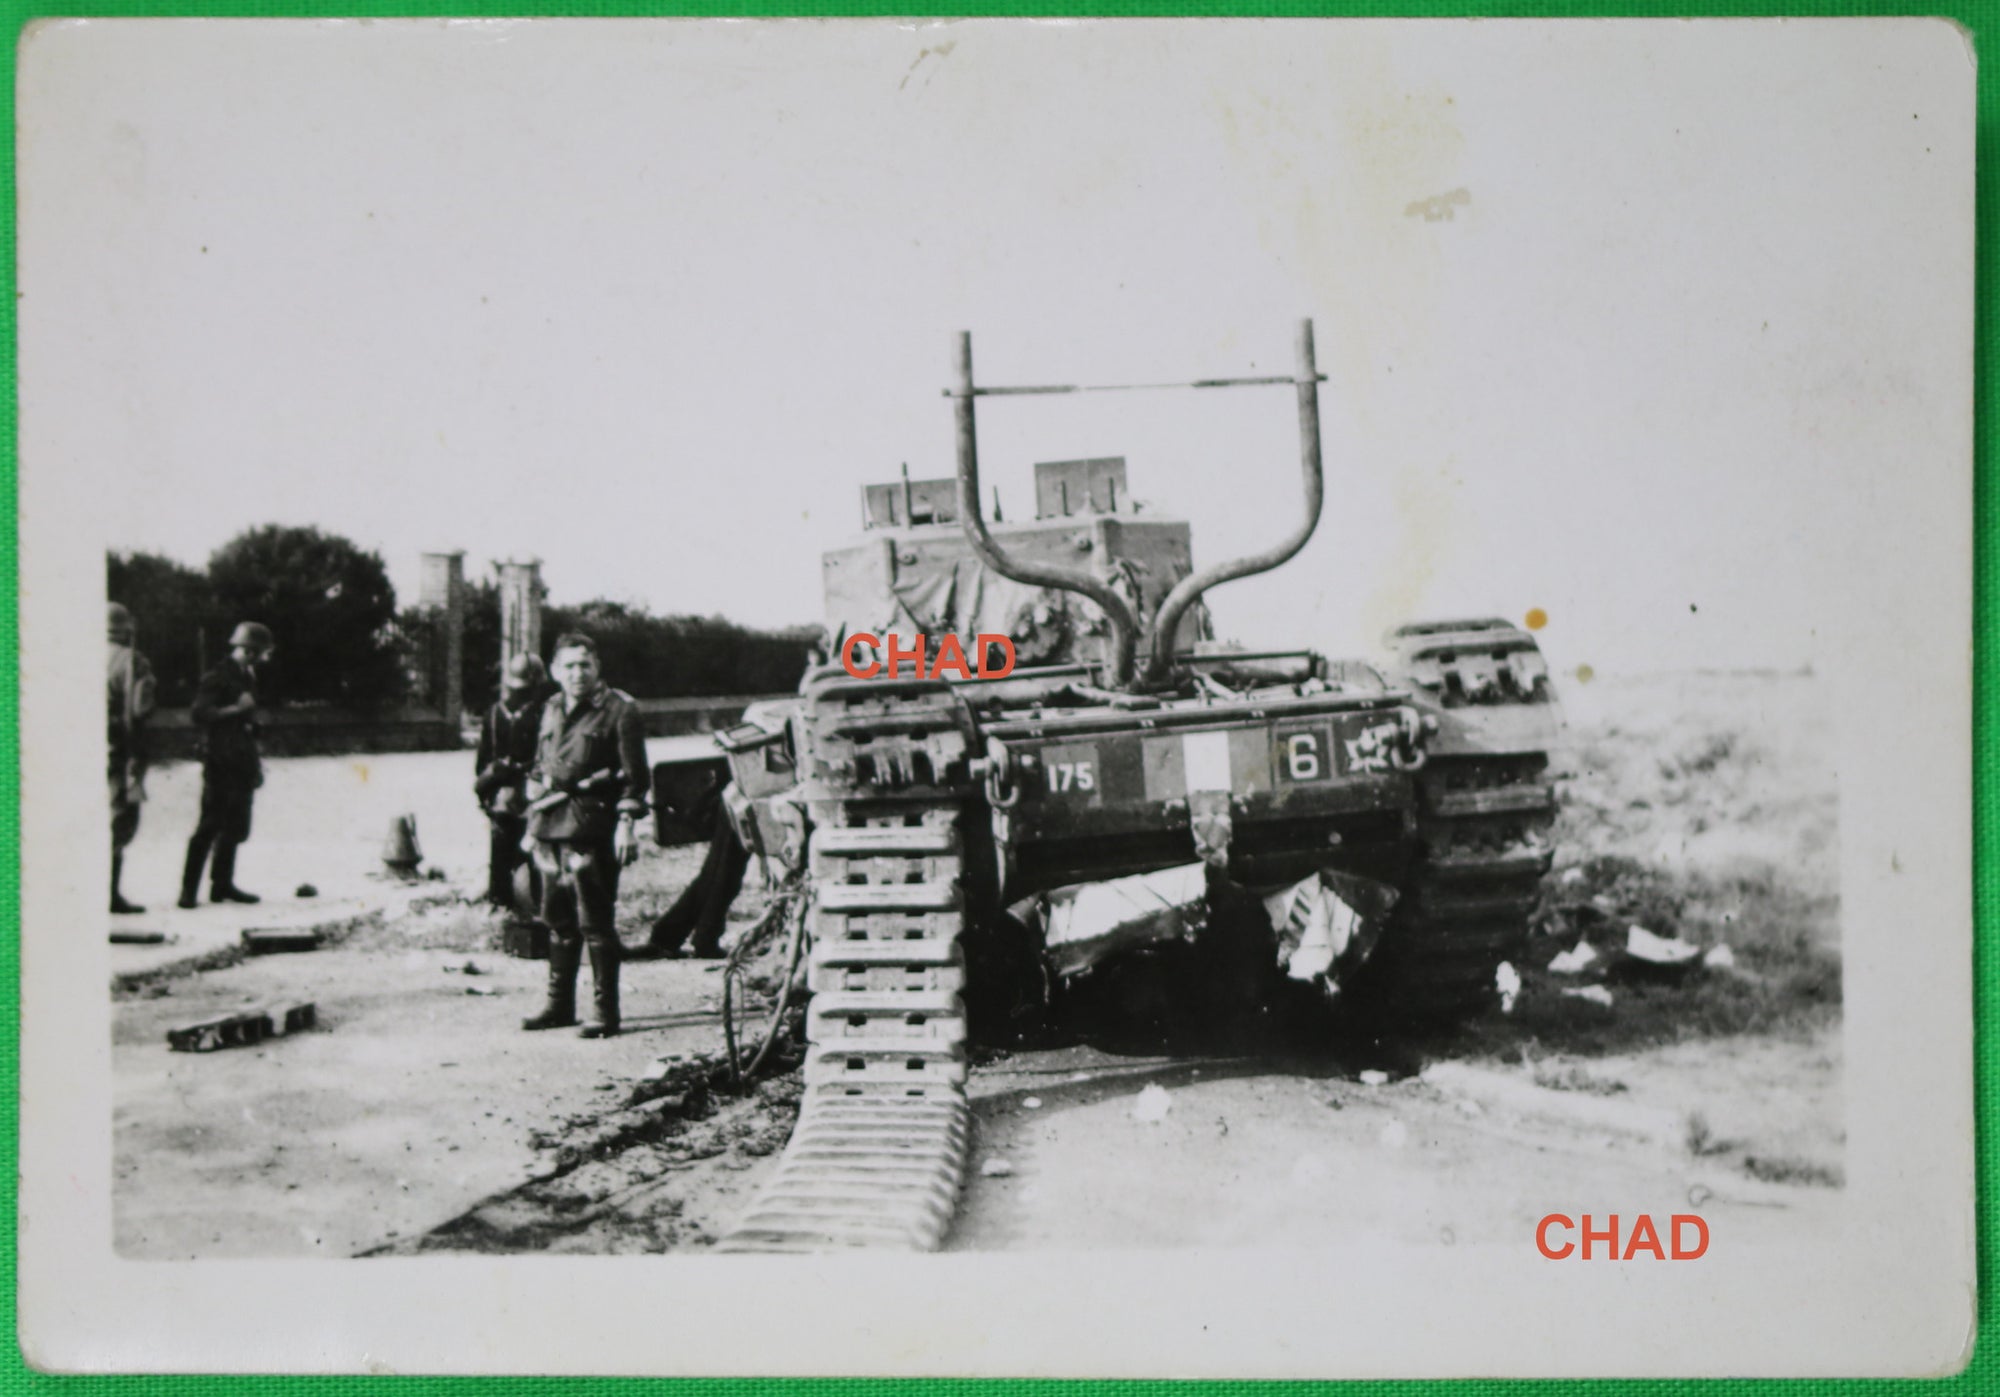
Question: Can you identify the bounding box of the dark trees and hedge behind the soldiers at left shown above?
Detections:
[106,524,820,713]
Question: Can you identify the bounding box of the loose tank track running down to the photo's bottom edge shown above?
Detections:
[716,799,970,1253]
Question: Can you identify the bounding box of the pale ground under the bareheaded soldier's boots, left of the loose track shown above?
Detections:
[112,896,748,1257]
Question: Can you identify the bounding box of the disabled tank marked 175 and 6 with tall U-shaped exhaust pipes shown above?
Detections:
[680,322,1558,1251]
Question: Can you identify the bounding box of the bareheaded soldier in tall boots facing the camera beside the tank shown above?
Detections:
[520,634,646,1039]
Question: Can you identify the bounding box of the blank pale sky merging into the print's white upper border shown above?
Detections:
[20,20,1972,672]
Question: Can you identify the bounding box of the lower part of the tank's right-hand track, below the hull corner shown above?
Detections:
[1350,753,1556,1023]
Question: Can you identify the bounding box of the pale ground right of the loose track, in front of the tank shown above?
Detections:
[950,1035,1840,1251]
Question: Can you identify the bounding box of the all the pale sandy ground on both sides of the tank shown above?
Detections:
[114,676,1844,1257]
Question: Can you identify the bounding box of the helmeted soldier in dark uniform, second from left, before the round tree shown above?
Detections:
[180,620,274,907]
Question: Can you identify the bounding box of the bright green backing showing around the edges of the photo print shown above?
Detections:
[0,0,2000,1397]
